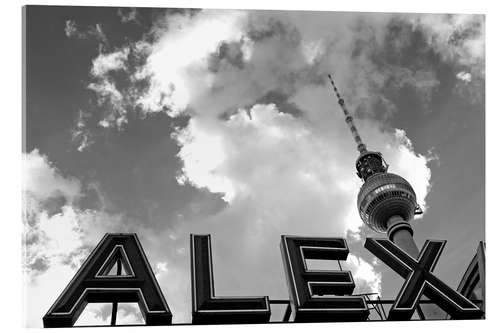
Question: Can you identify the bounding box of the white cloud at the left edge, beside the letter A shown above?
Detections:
[23,149,123,327]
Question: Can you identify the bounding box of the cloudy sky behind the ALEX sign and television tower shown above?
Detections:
[23,6,485,327]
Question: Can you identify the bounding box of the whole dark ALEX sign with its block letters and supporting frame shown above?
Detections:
[43,234,485,327]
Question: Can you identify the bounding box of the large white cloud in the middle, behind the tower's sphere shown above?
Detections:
[176,104,430,233]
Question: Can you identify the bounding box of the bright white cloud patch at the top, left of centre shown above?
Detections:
[137,10,246,115]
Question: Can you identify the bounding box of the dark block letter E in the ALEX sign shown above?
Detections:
[281,236,369,322]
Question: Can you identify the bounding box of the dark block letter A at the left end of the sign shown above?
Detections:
[43,234,172,327]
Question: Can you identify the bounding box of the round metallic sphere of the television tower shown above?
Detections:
[358,172,418,232]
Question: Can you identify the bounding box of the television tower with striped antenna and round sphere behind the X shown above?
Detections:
[328,74,422,258]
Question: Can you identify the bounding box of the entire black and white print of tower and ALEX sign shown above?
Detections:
[19,2,488,329]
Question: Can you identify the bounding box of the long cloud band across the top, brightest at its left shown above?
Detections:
[83,10,484,126]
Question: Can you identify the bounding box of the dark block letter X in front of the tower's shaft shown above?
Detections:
[365,238,483,320]
